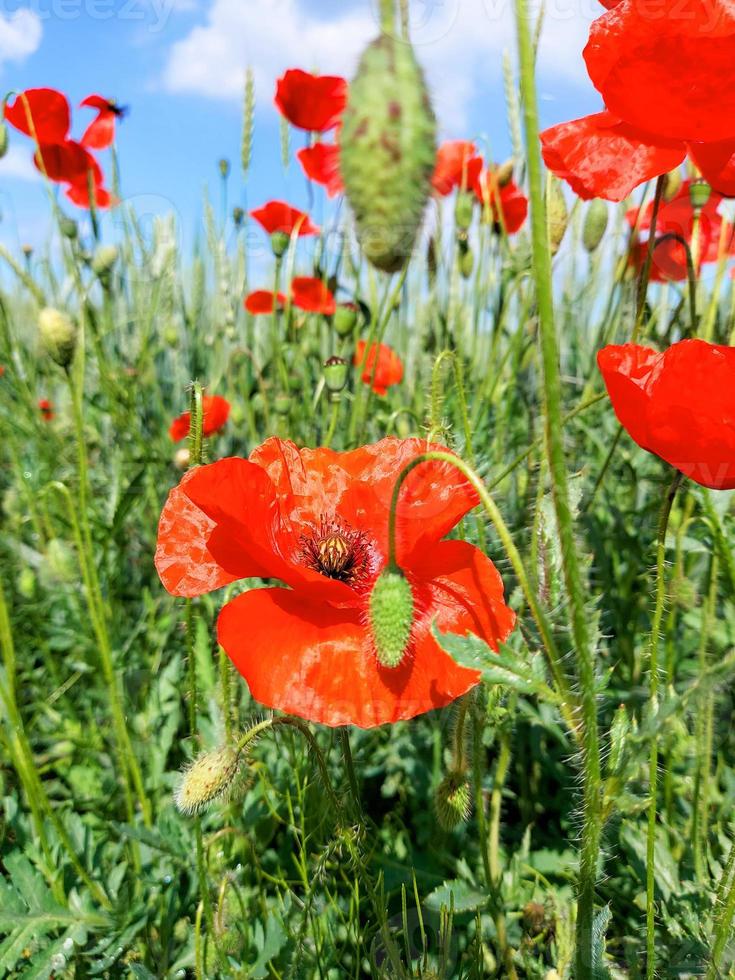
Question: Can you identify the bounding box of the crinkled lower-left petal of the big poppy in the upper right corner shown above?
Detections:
[541,112,686,201]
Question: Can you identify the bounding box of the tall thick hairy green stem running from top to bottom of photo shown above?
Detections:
[515,0,602,964]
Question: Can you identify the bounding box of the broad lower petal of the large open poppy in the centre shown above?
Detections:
[217,589,479,728]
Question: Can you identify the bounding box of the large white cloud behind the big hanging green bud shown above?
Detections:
[164,0,602,135]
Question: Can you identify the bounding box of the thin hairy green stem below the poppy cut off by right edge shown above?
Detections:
[646,473,684,980]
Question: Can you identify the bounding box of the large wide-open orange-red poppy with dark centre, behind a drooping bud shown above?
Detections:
[155,439,515,728]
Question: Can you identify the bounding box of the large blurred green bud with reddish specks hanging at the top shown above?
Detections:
[340,34,436,272]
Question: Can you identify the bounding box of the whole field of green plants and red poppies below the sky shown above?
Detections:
[0,0,735,980]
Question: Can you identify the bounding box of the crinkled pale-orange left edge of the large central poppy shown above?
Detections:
[154,470,242,597]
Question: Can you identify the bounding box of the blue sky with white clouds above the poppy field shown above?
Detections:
[0,0,602,253]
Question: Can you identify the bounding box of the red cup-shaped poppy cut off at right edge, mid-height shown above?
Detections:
[597,340,735,490]
